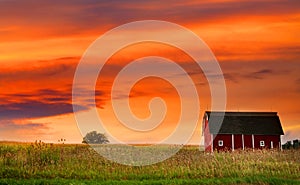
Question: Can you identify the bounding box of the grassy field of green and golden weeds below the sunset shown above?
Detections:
[0,143,300,185]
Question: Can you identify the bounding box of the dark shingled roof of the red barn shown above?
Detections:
[205,111,284,135]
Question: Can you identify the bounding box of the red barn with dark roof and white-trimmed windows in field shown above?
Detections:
[202,111,284,152]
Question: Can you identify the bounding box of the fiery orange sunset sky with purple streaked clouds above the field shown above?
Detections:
[0,0,300,144]
